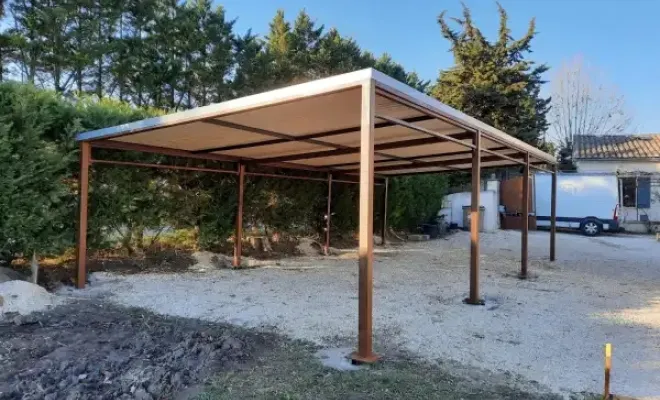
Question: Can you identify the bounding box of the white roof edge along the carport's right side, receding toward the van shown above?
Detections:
[371,70,557,164]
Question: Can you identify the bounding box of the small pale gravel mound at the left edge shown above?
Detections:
[0,281,59,320]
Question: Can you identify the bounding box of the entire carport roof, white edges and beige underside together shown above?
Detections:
[77,69,555,176]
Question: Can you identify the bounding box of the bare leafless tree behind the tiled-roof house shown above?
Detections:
[550,57,632,151]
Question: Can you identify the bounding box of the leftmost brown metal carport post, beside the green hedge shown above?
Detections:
[76,142,92,289]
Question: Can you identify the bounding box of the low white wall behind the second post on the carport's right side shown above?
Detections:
[439,190,500,232]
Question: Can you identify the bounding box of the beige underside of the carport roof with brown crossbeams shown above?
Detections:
[96,87,544,176]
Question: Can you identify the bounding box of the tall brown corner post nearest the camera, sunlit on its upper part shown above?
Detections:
[351,80,378,363]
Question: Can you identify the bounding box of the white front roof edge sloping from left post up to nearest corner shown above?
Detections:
[76,68,373,141]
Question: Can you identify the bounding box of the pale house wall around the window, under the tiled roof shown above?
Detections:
[575,161,660,223]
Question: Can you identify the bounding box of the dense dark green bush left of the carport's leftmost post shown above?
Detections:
[0,90,75,260]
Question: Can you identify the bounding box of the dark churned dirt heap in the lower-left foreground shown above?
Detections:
[0,301,270,400]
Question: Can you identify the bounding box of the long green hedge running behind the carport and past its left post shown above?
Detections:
[0,83,447,259]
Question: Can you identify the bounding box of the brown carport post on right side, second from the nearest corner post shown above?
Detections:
[465,131,484,305]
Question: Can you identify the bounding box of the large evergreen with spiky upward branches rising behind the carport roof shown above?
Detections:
[431,4,550,146]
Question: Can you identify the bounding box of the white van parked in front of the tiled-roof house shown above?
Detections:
[534,173,619,236]
